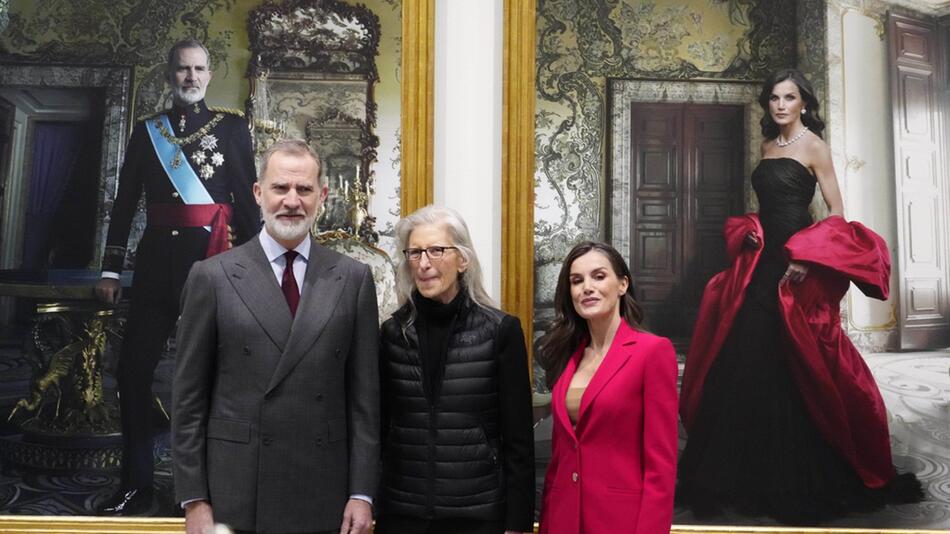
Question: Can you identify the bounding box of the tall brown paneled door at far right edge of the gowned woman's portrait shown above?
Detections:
[888,14,950,349]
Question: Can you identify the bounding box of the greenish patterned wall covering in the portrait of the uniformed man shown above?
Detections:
[0,0,402,260]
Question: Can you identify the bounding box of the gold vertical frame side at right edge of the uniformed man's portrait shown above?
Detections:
[400,0,435,215]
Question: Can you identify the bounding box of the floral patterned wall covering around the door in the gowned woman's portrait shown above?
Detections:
[535,0,804,358]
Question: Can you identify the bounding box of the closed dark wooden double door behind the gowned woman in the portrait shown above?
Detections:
[629,103,745,343]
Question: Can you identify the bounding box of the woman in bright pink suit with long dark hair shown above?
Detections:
[539,242,677,534]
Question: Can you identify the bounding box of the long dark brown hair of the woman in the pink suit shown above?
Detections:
[538,241,643,388]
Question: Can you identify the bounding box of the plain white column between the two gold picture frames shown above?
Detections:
[433,0,504,301]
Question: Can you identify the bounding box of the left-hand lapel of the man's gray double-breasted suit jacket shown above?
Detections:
[221,237,291,352]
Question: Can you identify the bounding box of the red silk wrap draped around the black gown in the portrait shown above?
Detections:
[680,214,895,488]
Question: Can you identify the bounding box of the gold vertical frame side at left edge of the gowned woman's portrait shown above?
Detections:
[501,0,535,369]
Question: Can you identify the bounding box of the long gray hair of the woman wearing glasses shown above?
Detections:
[396,204,496,323]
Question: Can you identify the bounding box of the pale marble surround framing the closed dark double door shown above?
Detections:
[607,80,762,264]
